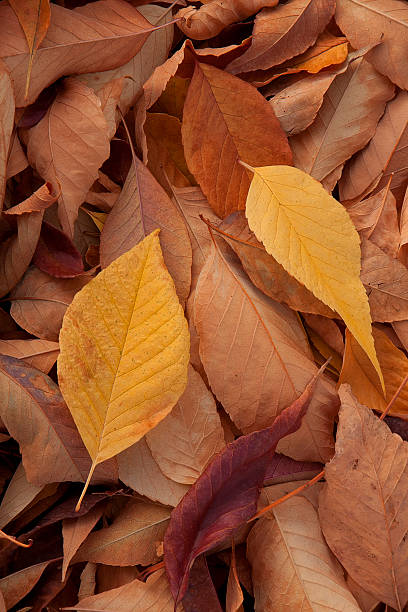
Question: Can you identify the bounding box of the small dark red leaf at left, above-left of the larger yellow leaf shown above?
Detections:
[33,222,84,278]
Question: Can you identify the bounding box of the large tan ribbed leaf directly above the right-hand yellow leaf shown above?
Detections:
[288,57,394,186]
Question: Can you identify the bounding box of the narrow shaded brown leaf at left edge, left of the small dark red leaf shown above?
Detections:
[0,212,43,297]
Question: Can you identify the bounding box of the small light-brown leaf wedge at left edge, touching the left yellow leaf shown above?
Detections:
[0,339,59,374]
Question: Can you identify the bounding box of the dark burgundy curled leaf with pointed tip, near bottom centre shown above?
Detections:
[164,369,322,604]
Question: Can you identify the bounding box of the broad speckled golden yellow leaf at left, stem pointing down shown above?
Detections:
[58,230,190,506]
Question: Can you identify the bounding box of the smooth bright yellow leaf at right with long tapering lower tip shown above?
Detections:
[241,162,384,388]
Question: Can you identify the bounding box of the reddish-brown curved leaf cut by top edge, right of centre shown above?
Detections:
[228,0,336,74]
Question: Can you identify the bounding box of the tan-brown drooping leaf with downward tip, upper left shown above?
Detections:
[27,78,109,238]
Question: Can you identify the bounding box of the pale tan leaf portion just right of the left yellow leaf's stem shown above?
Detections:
[117,438,188,507]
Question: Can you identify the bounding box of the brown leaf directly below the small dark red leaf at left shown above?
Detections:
[10,268,90,341]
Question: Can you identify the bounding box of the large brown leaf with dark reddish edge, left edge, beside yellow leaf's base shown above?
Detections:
[0,355,113,486]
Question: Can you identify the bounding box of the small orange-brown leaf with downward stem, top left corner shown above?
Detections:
[9,0,51,97]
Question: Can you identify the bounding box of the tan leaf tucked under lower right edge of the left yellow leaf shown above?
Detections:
[146,366,225,484]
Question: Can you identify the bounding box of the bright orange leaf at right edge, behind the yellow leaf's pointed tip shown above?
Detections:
[339,328,408,417]
